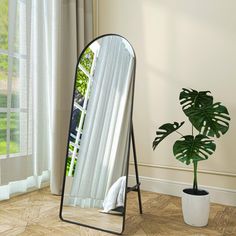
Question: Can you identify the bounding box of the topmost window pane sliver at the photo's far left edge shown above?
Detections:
[0,0,8,49]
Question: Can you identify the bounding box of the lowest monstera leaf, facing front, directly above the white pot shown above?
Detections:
[173,134,216,165]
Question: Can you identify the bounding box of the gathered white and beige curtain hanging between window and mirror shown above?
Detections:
[32,0,77,193]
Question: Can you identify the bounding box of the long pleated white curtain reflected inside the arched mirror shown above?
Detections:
[69,36,134,207]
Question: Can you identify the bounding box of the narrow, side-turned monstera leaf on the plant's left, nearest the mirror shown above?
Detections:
[152,121,184,150]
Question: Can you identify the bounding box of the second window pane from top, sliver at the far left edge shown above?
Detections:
[0,55,8,107]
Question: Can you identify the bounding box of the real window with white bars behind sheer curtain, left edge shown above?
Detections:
[0,0,31,158]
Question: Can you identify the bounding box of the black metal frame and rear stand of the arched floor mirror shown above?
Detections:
[59,33,142,235]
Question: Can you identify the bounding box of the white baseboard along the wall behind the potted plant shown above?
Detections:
[129,175,236,206]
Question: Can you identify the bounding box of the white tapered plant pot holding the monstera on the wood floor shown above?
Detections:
[182,190,210,227]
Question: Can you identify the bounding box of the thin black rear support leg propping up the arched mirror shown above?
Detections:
[127,122,143,214]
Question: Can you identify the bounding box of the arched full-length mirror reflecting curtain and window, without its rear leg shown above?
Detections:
[60,35,135,233]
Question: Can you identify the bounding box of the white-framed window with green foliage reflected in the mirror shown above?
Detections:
[67,42,99,176]
